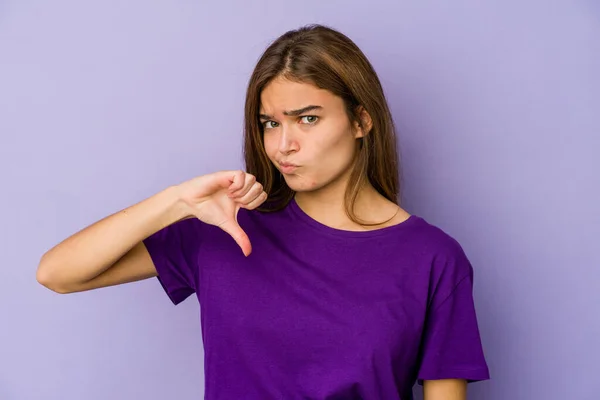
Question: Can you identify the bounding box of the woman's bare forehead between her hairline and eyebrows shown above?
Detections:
[260,78,341,114]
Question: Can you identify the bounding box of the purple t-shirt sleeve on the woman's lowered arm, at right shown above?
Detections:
[417,244,489,384]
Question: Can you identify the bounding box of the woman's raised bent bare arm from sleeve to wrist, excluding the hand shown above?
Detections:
[36,186,191,293]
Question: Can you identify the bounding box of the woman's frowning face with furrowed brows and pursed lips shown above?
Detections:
[260,78,363,192]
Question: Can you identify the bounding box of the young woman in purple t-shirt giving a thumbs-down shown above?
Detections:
[37,26,489,400]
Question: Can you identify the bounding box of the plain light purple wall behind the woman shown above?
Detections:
[0,0,600,400]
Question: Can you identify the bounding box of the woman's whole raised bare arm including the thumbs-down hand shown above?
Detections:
[37,170,267,293]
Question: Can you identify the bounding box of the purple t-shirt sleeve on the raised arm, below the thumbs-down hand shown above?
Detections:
[143,218,202,305]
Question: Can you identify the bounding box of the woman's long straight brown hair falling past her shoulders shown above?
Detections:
[244,25,400,225]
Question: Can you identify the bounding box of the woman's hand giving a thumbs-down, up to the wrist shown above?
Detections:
[178,171,267,256]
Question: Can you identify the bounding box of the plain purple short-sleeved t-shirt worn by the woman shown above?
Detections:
[144,200,489,400]
